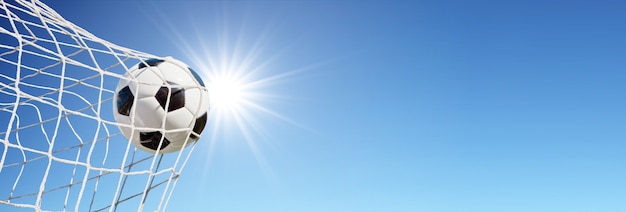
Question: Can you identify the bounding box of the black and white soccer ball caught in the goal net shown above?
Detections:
[113,57,209,153]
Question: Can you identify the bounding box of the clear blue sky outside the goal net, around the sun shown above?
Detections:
[23,0,626,212]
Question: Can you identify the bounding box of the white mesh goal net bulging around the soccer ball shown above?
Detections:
[0,0,200,211]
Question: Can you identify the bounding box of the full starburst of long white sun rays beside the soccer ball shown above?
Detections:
[143,2,321,181]
